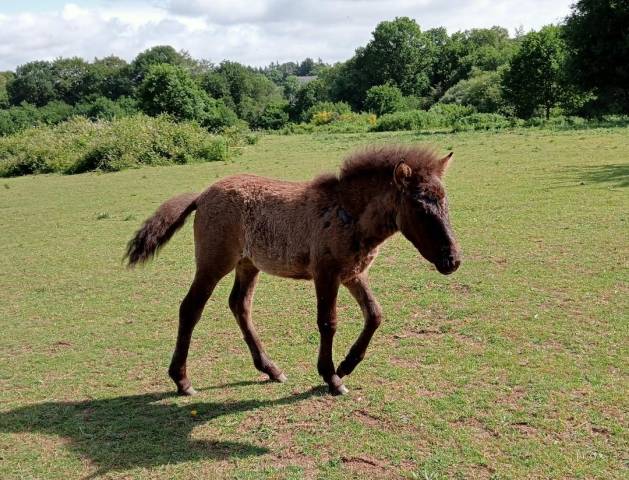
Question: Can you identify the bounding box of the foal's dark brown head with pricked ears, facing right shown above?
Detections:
[393,150,461,275]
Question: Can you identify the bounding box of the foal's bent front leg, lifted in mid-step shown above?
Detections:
[337,274,382,378]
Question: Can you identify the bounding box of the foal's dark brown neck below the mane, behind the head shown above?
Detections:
[340,175,398,249]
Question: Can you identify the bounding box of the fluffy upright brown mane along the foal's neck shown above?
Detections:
[339,145,440,181]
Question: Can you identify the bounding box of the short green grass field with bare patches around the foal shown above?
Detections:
[0,128,629,479]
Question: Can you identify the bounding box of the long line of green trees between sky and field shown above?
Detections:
[0,0,629,135]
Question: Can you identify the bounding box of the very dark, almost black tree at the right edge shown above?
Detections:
[565,0,629,113]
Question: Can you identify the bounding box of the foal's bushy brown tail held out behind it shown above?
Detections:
[124,193,199,267]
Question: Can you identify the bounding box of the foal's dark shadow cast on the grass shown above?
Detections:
[0,387,325,477]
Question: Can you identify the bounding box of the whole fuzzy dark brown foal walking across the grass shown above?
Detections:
[127,146,460,395]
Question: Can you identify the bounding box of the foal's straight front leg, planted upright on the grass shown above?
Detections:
[315,275,347,395]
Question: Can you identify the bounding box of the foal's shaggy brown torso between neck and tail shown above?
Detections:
[195,175,322,278]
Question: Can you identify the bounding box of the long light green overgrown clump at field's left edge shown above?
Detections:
[0,114,230,177]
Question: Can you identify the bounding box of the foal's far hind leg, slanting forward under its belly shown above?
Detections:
[229,259,286,382]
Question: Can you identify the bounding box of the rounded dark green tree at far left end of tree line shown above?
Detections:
[7,61,56,107]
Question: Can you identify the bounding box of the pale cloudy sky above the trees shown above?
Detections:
[0,0,574,71]
